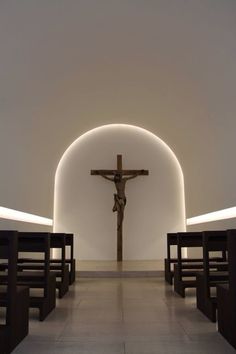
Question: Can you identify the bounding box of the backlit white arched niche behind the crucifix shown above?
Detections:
[54,124,185,260]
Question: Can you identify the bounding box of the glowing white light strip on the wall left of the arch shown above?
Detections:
[0,207,53,226]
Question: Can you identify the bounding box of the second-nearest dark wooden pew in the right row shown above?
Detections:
[196,231,228,322]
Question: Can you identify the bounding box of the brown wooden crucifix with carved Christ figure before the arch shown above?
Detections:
[91,155,148,262]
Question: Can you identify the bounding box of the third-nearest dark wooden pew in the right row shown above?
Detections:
[174,232,225,297]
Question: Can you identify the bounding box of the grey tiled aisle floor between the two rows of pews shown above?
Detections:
[13,278,236,354]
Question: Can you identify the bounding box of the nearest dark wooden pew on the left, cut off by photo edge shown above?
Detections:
[0,231,29,354]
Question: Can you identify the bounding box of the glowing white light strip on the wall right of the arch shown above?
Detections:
[187,207,236,225]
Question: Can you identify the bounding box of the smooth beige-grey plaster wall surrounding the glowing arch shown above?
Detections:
[0,0,236,229]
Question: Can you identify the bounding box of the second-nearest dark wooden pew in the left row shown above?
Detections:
[17,232,56,321]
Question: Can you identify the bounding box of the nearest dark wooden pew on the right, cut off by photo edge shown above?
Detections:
[217,230,236,349]
